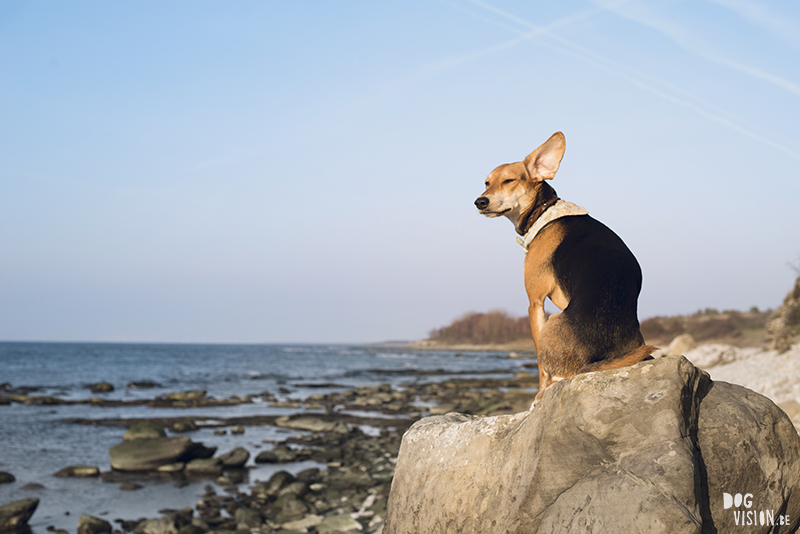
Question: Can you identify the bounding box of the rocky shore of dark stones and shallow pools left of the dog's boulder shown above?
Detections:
[0,344,538,534]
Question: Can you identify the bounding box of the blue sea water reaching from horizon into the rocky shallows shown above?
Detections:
[0,342,531,534]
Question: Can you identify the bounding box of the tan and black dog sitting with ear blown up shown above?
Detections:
[475,132,656,403]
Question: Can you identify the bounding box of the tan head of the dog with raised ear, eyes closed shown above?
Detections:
[475,132,567,234]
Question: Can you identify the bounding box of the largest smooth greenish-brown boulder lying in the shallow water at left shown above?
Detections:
[108,436,216,471]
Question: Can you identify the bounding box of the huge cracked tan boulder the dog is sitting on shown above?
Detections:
[383,356,800,534]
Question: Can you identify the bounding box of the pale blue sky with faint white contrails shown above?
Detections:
[0,0,800,343]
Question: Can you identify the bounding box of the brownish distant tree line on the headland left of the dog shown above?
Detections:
[428,310,531,345]
